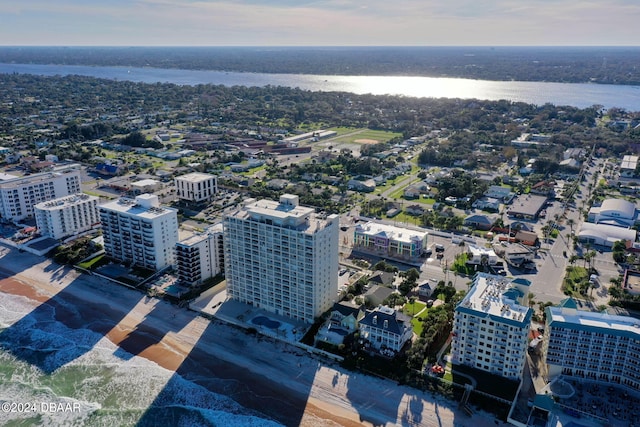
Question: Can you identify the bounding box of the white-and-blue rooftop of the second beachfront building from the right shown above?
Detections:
[456,273,532,325]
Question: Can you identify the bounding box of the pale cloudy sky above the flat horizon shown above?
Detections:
[0,0,640,46]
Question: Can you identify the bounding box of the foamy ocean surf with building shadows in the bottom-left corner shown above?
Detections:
[0,293,280,427]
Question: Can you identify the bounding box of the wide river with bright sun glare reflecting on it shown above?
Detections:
[0,63,640,111]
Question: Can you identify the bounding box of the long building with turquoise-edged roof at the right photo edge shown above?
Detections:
[542,298,640,390]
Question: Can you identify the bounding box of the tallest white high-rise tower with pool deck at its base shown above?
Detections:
[224,194,339,323]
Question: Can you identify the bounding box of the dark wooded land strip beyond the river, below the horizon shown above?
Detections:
[0,46,640,85]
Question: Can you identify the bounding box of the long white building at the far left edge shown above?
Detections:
[0,164,80,221]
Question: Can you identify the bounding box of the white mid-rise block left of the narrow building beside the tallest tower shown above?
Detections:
[99,194,178,270]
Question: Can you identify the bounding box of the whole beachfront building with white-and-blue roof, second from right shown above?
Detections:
[451,273,533,380]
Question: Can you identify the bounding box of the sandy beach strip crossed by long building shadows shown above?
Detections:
[0,244,502,427]
